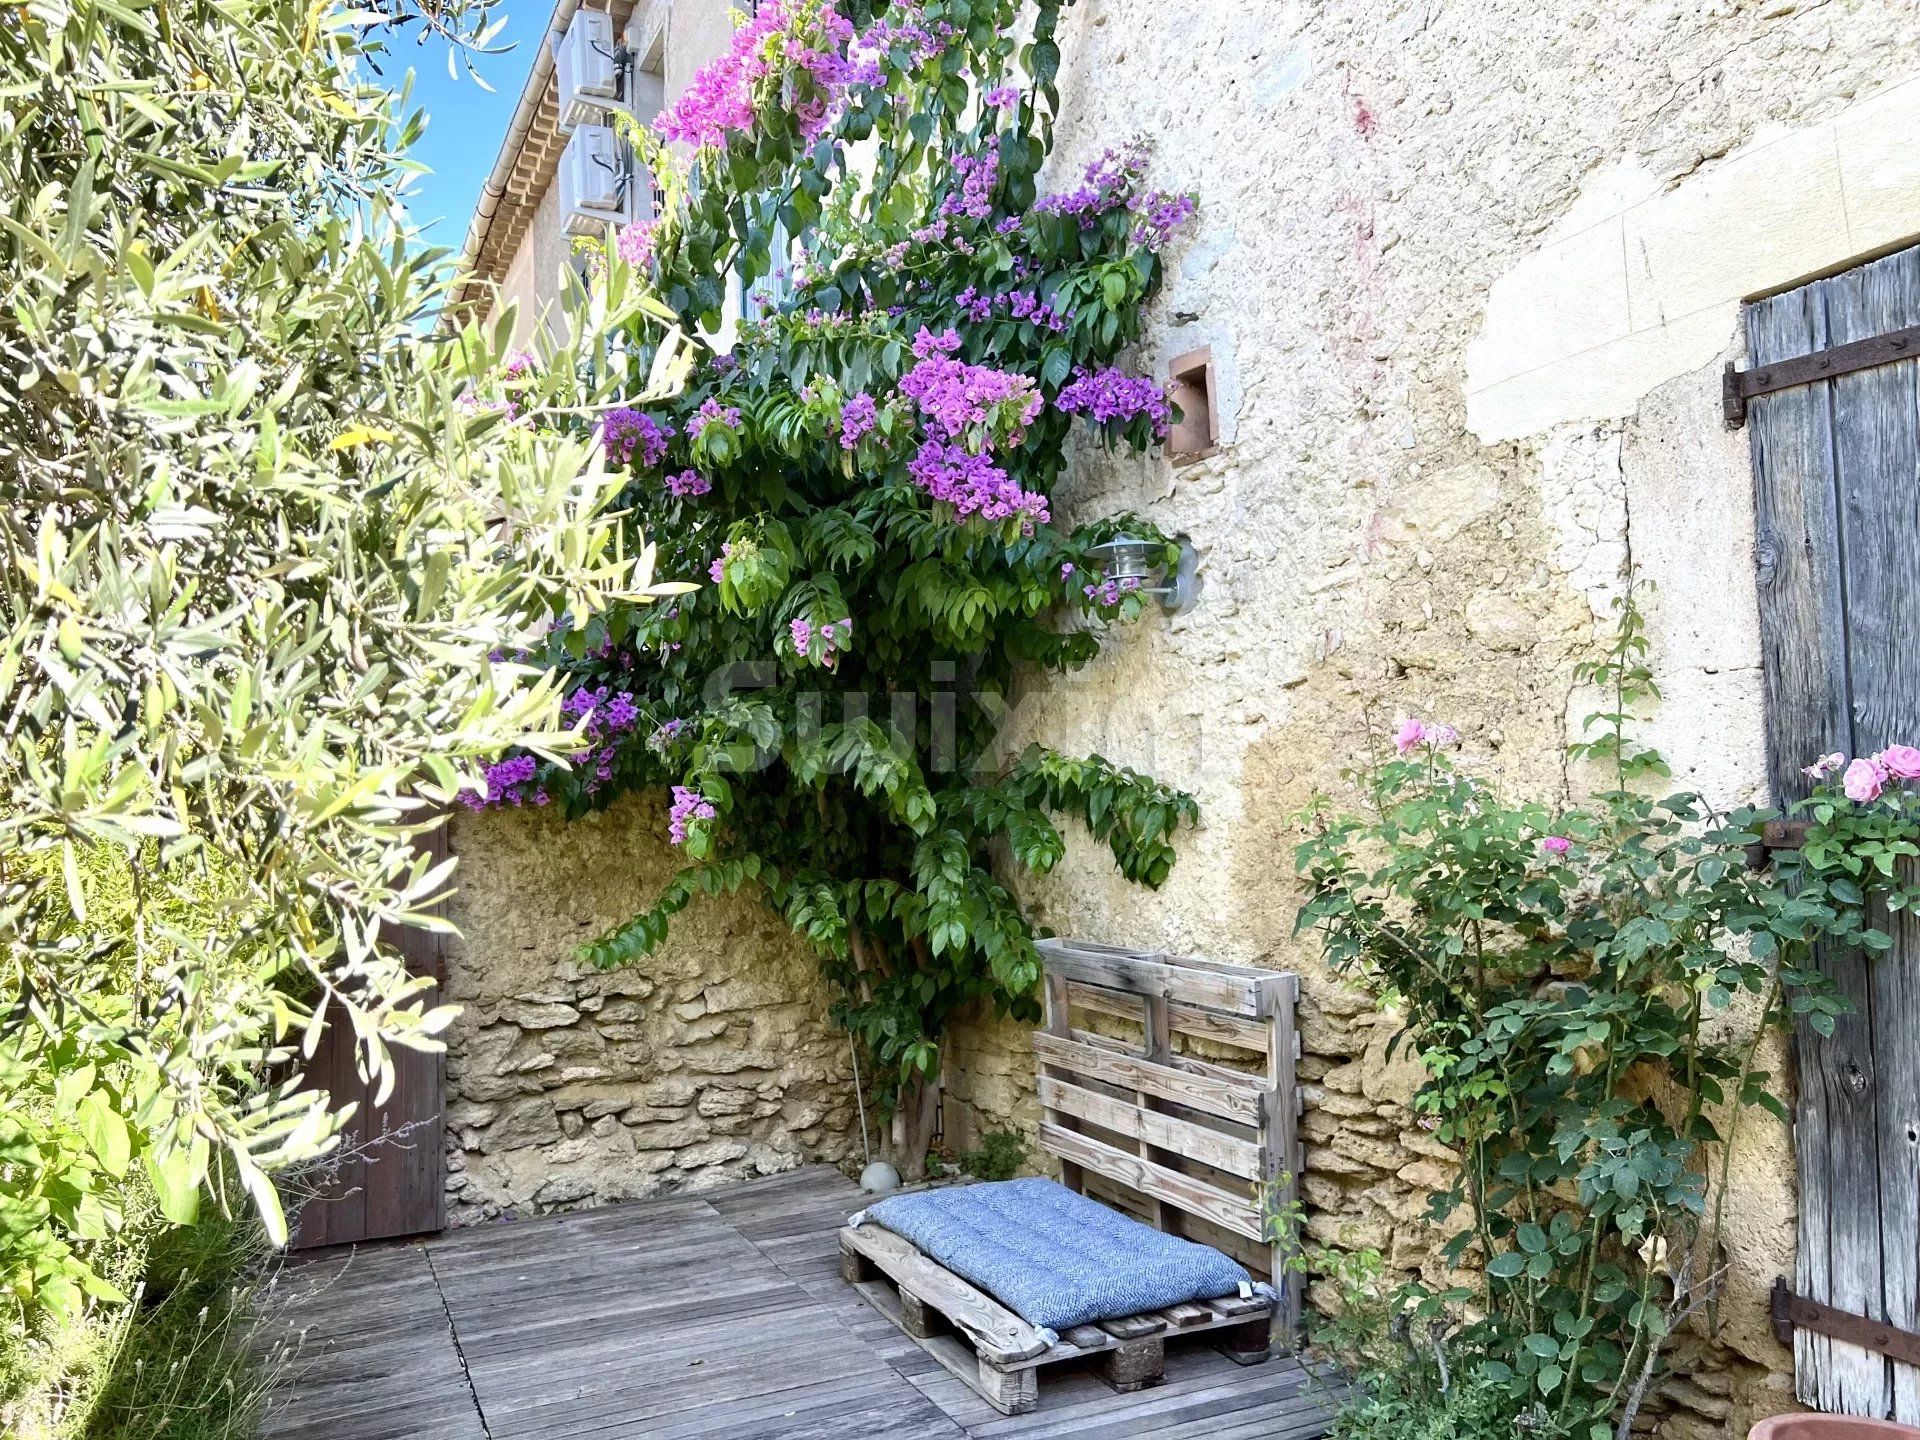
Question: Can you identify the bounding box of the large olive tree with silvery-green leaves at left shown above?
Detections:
[0,0,676,1327]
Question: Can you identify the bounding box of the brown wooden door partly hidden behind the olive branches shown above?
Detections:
[292,824,447,1250]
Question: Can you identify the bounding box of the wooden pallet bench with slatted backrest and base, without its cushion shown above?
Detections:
[841,941,1300,1415]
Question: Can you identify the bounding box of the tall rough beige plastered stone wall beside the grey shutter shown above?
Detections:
[947,0,1920,1436]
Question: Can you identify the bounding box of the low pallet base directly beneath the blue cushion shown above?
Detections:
[841,1225,1273,1415]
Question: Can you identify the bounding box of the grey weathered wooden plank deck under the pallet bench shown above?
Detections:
[263,1167,1332,1440]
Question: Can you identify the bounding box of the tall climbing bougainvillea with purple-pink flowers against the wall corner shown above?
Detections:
[474,0,1196,1158]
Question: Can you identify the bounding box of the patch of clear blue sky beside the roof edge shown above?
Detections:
[396,0,553,252]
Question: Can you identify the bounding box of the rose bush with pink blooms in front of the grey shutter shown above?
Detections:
[1298,587,1920,1440]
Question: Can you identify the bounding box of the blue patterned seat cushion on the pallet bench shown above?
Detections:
[854,1179,1252,1331]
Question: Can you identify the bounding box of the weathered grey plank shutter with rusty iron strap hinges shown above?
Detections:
[1745,250,1920,1423]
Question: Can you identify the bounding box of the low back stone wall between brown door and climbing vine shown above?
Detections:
[447,797,858,1225]
